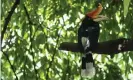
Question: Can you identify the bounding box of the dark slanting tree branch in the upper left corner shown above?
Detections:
[1,0,20,43]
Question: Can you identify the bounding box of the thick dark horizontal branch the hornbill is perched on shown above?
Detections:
[59,38,133,54]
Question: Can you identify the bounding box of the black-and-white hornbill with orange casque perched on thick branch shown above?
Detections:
[78,3,107,77]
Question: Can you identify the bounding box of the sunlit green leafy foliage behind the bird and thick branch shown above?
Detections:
[1,0,133,80]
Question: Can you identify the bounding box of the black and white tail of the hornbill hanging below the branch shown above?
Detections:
[81,52,95,78]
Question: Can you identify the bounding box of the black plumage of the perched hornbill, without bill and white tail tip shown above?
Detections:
[78,15,100,76]
